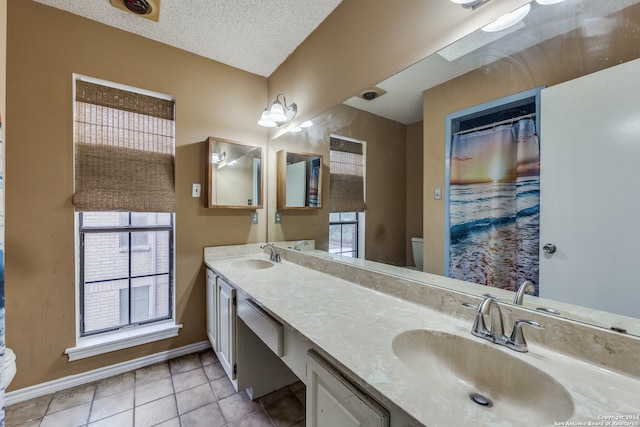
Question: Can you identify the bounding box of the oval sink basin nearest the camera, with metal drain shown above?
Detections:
[392,329,574,425]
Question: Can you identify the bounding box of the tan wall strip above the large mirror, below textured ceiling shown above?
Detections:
[269,0,530,135]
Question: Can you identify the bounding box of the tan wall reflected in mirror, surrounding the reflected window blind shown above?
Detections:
[268,104,408,265]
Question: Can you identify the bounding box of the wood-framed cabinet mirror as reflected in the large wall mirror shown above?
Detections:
[276,150,322,210]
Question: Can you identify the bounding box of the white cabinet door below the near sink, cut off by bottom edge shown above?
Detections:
[307,351,389,427]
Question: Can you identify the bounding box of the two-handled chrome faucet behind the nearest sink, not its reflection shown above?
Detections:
[463,296,544,353]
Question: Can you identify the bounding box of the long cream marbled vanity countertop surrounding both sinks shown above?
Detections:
[205,253,640,426]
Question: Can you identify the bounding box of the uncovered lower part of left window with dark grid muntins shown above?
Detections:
[78,212,173,336]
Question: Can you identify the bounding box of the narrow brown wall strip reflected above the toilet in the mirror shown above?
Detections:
[406,122,424,266]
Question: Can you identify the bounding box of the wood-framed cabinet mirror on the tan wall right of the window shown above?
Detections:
[206,137,264,210]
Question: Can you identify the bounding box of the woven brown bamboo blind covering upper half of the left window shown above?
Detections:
[73,80,175,212]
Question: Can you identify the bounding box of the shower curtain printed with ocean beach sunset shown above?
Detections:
[449,119,540,295]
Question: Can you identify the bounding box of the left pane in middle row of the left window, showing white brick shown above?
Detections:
[84,233,129,283]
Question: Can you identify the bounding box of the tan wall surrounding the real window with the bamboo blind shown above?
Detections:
[6,0,267,389]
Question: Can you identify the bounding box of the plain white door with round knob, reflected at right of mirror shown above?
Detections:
[540,56,640,317]
